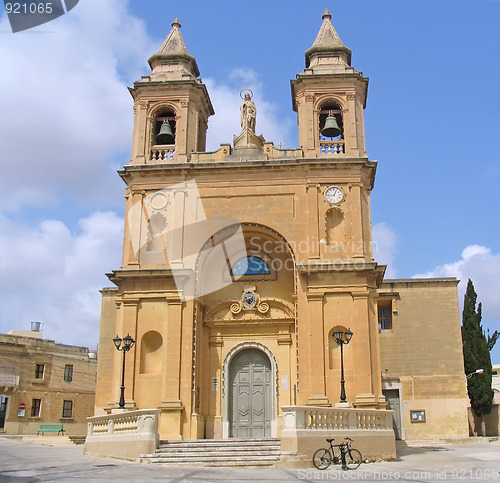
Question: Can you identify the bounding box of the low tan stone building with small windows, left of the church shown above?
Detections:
[0,323,97,435]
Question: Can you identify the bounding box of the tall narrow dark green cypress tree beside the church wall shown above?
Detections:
[462,280,493,436]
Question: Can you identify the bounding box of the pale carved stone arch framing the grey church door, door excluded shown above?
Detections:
[222,341,278,439]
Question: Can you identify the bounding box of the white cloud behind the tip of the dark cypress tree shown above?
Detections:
[414,245,500,320]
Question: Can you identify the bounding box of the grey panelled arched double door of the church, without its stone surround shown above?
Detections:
[228,349,272,438]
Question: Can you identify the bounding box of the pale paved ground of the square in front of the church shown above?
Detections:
[0,437,500,483]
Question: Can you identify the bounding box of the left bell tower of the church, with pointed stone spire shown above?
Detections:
[129,19,214,164]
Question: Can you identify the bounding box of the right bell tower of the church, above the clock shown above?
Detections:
[291,9,368,158]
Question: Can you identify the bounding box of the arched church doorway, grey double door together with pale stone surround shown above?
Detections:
[222,342,277,438]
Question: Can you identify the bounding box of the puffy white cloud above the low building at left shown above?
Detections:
[0,212,123,347]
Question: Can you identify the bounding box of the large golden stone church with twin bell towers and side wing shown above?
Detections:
[95,10,468,460]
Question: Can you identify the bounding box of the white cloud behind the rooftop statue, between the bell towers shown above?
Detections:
[203,68,296,151]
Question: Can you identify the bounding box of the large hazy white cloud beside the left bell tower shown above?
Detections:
[0,0,158,210]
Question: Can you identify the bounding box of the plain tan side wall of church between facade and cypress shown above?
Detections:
[379,279,468,439]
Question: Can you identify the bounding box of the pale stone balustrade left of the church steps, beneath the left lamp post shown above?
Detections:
[85,409,160,460]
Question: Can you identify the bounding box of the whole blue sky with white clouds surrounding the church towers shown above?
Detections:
[0,0,500,362]
